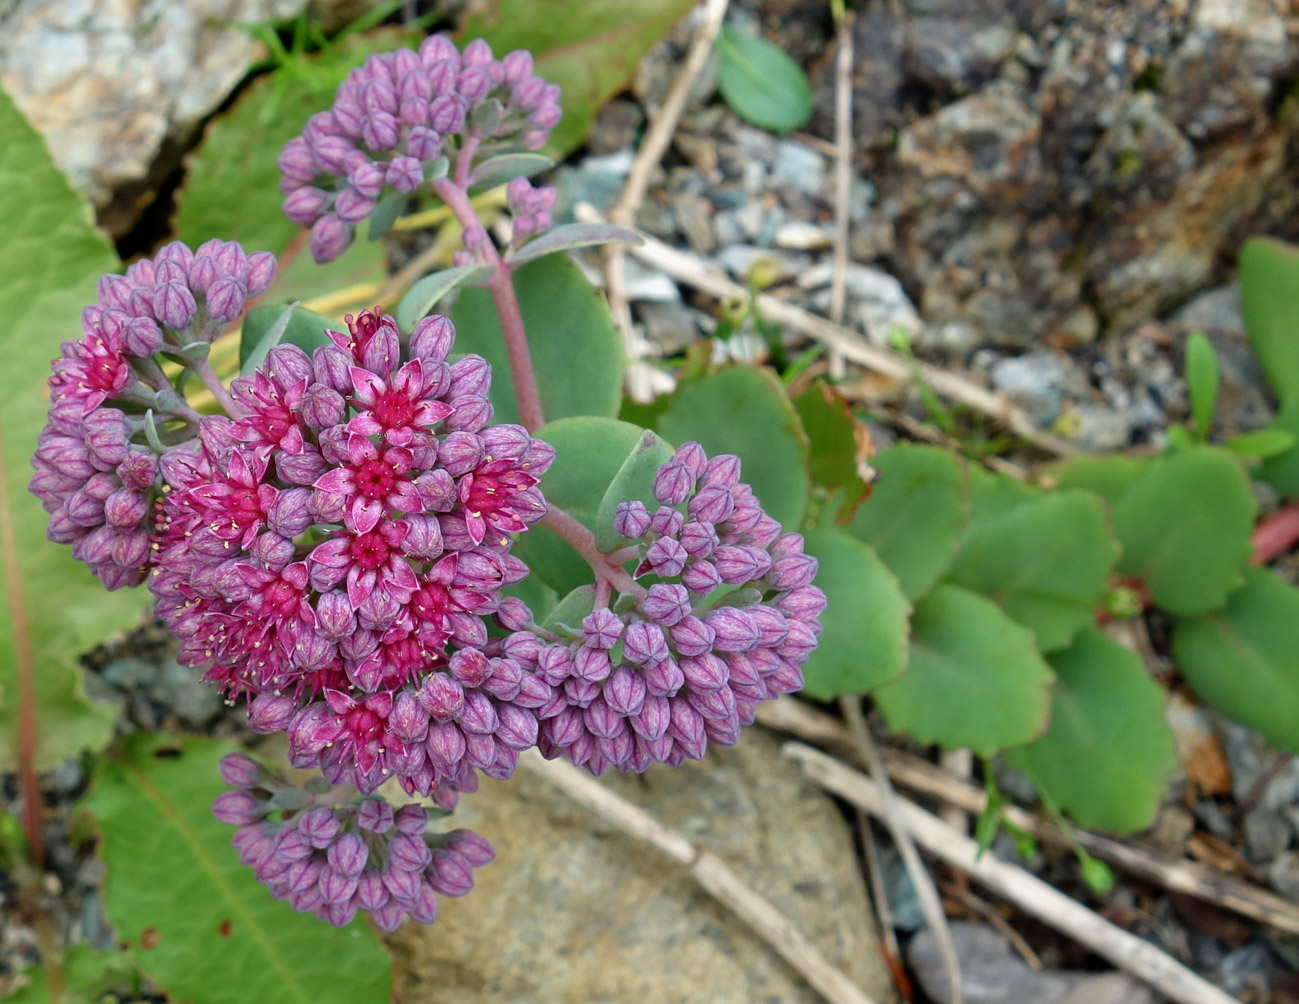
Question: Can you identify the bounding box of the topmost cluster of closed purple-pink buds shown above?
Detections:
[278,35,561,262]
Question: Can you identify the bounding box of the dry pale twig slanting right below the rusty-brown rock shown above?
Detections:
[574,204,1078,456]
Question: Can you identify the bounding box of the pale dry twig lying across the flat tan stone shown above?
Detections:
[518,749,873,1004]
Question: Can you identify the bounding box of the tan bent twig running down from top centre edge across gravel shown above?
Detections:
[604,0,727,379]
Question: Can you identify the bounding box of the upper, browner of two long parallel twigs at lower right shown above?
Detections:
[757,697,1299,934]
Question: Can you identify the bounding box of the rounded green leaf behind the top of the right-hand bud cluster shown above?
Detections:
[659,366,808,529]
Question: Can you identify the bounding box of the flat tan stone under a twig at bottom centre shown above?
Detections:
[390,729,894,1004]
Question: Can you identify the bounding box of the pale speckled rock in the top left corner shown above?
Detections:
[0,0,303,230]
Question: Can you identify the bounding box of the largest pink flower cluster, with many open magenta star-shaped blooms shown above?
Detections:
[149,305,555,800]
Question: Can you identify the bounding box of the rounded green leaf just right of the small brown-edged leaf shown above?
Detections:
[848,443,970,600]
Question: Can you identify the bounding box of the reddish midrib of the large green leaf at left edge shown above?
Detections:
[0,418,45,868]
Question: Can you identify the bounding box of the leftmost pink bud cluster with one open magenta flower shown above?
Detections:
[30,240,275,590]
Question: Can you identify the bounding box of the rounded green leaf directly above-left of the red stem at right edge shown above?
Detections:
[1113,447,1257,617]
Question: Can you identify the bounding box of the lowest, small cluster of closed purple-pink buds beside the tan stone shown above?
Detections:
[212,753,495,931]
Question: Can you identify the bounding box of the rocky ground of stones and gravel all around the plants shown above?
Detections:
[0,0,1299,1004]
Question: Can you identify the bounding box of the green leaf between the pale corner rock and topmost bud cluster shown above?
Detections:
[175,29,421,255]
